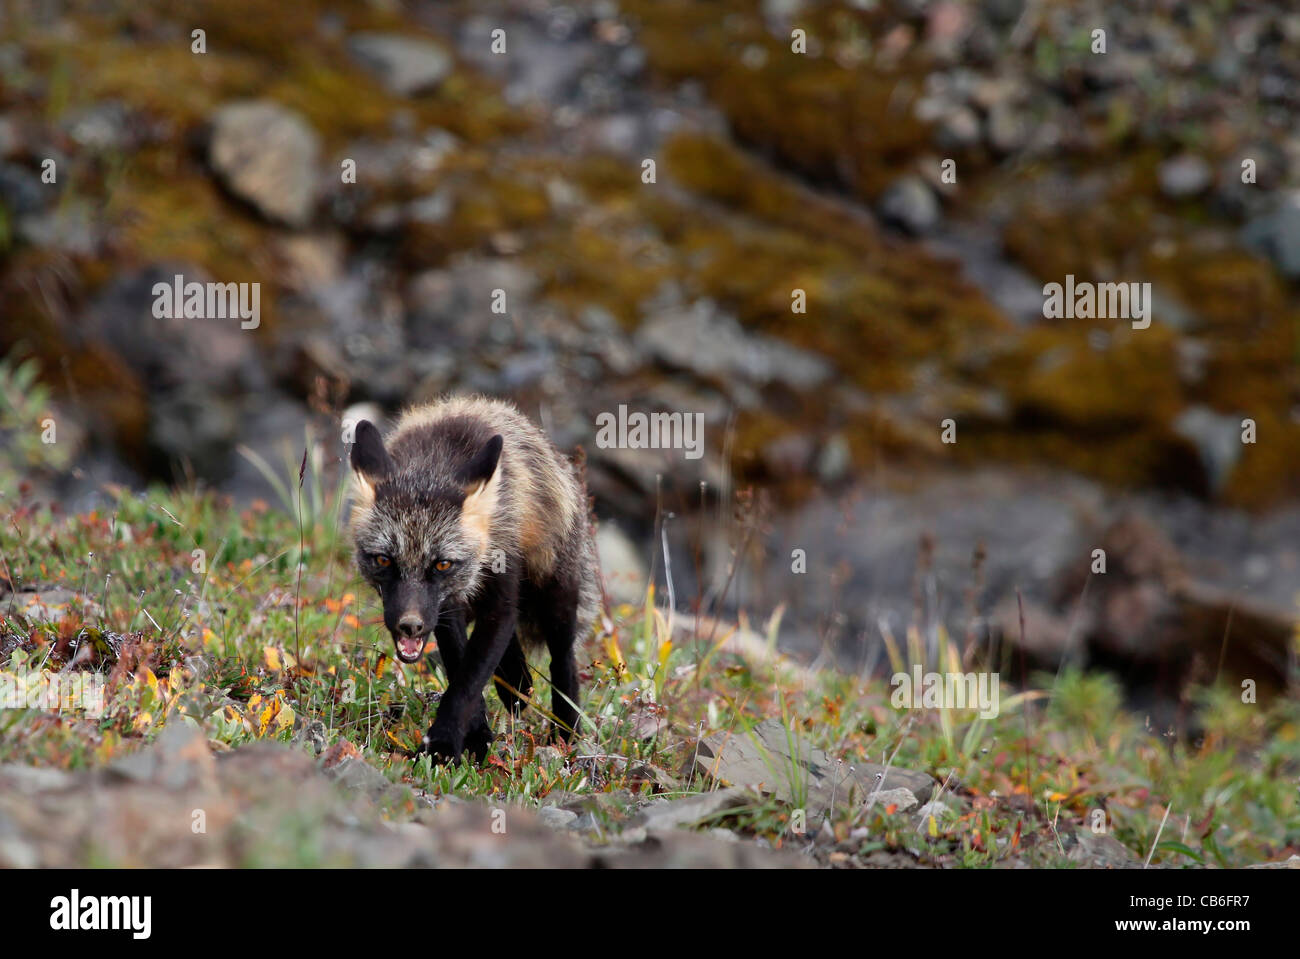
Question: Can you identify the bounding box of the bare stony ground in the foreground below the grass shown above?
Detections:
[0,696,1138,868]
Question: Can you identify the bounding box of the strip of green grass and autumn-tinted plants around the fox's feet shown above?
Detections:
[0,461,1300,867]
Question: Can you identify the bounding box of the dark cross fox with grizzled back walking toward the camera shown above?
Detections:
[351,396,601,763]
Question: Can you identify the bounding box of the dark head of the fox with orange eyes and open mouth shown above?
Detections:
[352,420,502,663]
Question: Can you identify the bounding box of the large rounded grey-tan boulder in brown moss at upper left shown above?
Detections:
[208,100,320,226]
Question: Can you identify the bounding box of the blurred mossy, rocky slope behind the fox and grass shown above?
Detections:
[0,0,1300,715]
